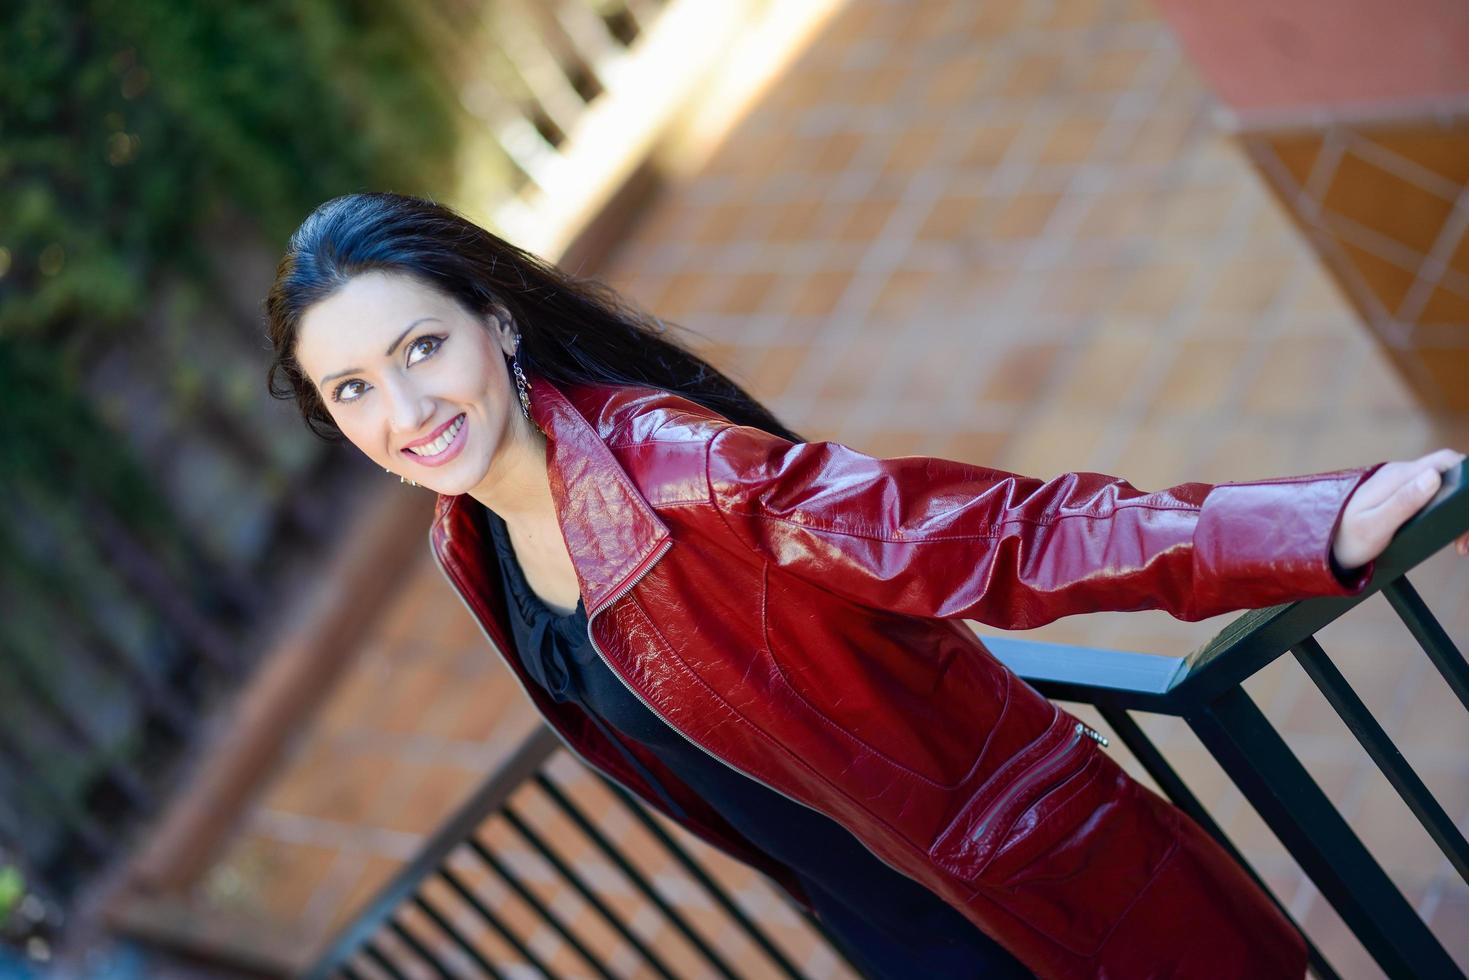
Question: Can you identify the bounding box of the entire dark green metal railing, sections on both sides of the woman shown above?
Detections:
[308,464,1469,980]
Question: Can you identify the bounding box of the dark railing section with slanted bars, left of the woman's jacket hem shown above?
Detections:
[306,726,861,980]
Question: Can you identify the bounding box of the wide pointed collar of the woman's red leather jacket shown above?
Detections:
[430,376,671,616]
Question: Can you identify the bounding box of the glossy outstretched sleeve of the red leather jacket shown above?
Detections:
[707,426,1381,629]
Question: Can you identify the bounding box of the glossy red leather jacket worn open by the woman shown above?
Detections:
[430,379,1375,980]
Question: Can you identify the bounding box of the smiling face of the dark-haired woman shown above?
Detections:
[295,272,529,494]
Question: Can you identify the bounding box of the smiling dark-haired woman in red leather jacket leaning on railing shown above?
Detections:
[266,194,1465,977]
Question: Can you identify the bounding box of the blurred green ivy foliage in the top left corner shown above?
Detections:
[0,0,457,338]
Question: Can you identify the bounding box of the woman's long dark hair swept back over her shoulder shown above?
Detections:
[264,192,802,442]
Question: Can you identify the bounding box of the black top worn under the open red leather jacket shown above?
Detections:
[485,508,1031,977]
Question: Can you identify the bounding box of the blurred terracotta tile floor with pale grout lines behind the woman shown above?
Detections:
[183,0,1469,977]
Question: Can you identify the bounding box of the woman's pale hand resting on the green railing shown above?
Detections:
[1331,450,1469,573]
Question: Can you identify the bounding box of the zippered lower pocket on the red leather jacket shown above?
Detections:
[930,713,1177,955]
